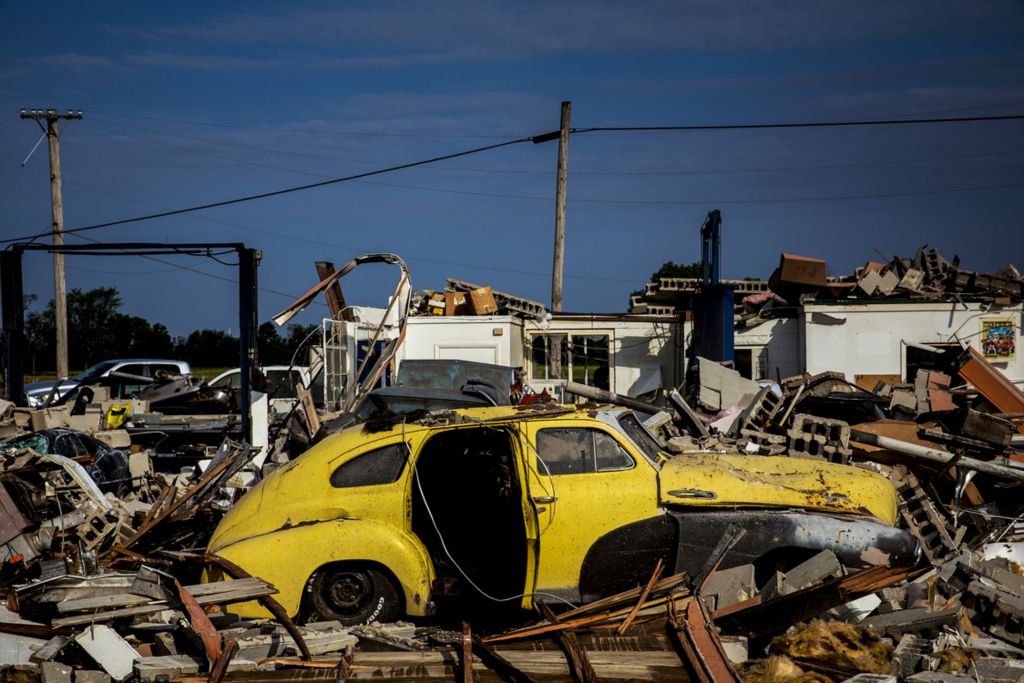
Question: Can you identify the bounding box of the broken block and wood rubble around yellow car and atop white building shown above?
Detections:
[0,249,1024,683]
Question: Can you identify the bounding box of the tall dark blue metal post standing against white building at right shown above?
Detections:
[690,209,735,362]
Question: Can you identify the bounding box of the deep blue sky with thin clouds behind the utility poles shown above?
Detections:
[0,0,1024,334]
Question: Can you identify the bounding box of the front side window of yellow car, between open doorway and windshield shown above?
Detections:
[537,427,635,475]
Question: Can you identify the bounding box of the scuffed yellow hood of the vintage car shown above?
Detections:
[659,455,897,525]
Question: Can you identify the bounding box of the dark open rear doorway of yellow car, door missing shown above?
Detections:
[412,427,526,598]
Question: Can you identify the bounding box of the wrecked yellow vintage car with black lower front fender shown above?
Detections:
[206,404,918,624]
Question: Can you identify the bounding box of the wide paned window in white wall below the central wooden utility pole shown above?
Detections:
[530,333,611,389]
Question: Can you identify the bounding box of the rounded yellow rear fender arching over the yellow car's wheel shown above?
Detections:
[204,518,434,617]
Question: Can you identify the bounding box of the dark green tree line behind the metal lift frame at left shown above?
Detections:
[25,287,319,374]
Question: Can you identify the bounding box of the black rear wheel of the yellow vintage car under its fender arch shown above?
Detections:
[309,565,400,626]
